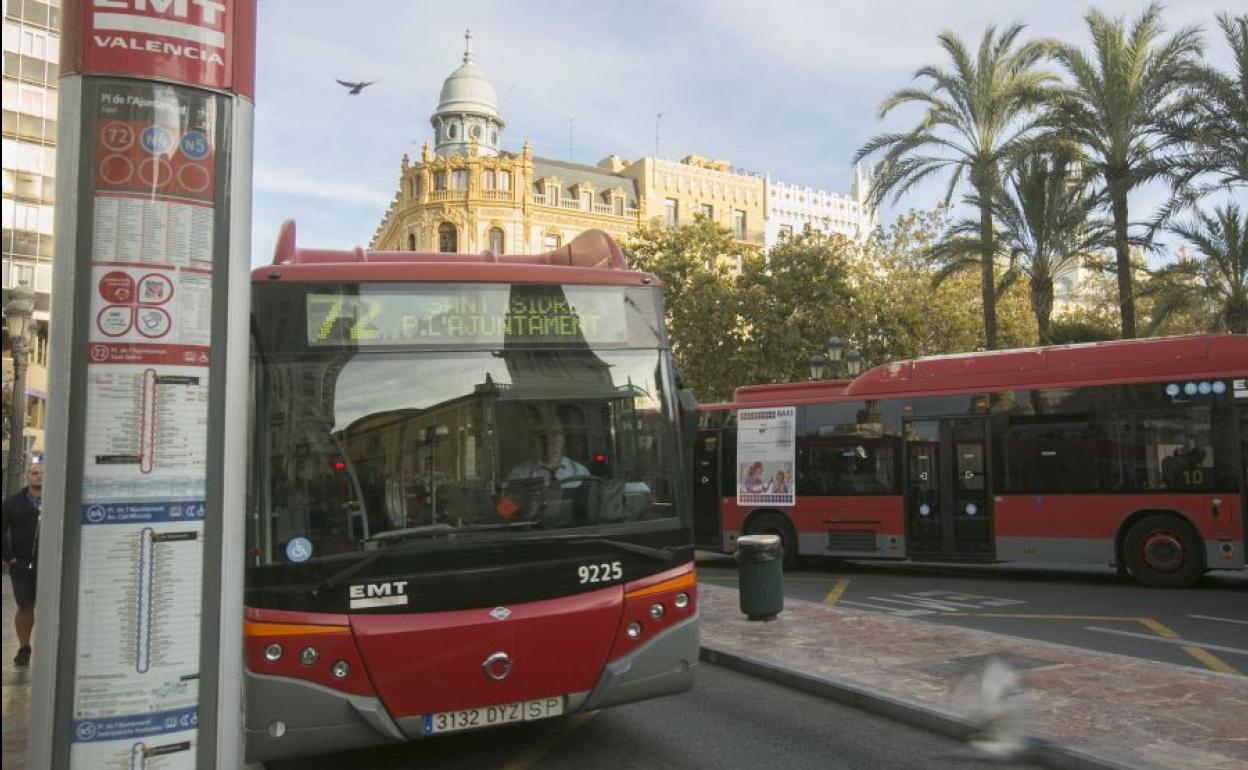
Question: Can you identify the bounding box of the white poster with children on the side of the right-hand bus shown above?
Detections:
[736,407,797,505]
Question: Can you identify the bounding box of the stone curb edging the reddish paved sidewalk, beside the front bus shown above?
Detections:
[700,644,1143,770]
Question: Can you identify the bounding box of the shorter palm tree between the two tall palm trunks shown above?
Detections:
[927,152,1108,344]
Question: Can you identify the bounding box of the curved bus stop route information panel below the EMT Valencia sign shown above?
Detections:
[70,82,220,769]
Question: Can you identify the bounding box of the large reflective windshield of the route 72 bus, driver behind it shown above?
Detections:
[250,287,685,567]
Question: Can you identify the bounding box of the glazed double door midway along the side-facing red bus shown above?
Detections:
[905,418,995,559]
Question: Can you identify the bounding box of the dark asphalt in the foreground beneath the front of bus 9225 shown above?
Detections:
[266,664,1032,770]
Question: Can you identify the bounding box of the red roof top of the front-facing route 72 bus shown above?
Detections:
[273,220,629,270]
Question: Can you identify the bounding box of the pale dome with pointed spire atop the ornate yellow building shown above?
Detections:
[429,31,504,156]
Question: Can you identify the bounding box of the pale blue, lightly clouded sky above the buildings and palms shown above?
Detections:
[245,0,1233,265]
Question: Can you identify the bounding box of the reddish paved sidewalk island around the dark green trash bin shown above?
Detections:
[698,583,1248,770]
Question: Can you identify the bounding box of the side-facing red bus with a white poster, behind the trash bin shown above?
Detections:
[693,334,1248,587]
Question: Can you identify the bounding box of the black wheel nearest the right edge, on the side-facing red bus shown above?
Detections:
[1122,513,1204,588]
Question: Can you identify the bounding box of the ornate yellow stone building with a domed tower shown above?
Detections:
[369,34,766,253]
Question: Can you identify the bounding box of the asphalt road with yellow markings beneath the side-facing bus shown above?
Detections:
[698,554,1248,674]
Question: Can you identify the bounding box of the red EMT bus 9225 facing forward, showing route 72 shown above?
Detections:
[245,223,698,761]
